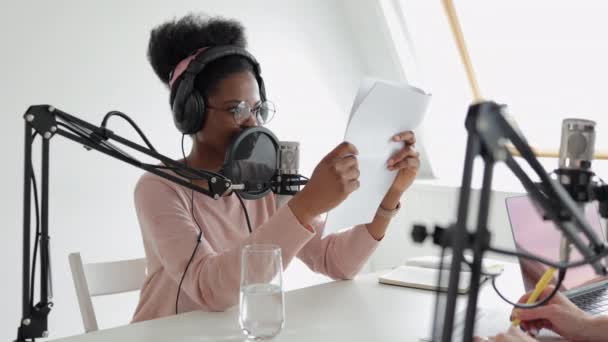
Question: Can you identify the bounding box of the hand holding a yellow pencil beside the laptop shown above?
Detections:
[512,286,608,341]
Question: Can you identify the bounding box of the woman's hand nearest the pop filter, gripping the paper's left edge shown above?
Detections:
[288,142,359,225]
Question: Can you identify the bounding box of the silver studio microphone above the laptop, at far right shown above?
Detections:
[555,119,595,203]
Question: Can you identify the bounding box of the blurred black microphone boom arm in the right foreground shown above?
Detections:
[420,101,608,342]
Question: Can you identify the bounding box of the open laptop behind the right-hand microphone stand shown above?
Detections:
[505,195,608,315]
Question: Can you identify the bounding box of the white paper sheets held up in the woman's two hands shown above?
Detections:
[323,79,430,236]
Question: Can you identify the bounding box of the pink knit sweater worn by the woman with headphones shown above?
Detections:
[133,173,378,322]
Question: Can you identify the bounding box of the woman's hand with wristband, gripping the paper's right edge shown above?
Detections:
[387,131,420,193]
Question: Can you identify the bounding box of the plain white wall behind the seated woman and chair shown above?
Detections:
[0,0,366,340]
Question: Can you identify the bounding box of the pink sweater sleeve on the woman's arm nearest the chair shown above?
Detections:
[135,178,313,311]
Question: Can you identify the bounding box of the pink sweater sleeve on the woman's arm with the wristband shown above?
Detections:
[298,217,379,279]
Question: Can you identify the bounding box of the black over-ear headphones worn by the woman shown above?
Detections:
[171,45,266,134]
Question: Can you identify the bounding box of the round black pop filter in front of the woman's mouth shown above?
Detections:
[221,126,279,199]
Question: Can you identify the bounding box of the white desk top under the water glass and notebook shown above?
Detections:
[52,264,523,342]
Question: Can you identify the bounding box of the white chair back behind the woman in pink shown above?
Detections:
[68,253,146,333]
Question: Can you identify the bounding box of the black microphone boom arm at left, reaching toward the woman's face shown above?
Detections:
[16,105,235,341]
